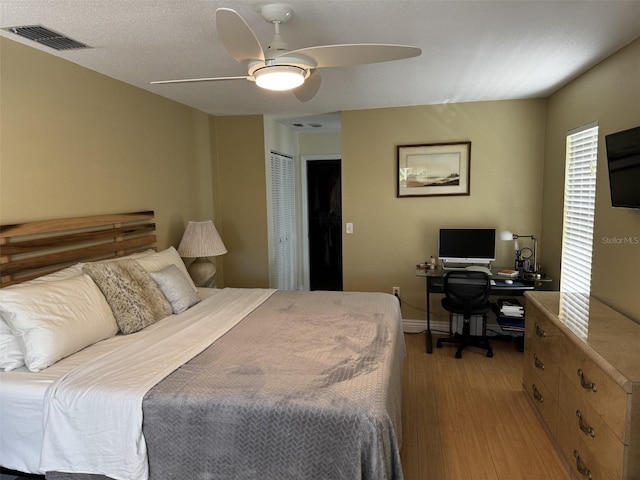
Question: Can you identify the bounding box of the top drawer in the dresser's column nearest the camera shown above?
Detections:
[561,341,629,444]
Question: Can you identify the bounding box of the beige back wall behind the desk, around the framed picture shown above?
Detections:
[342,100,546,319]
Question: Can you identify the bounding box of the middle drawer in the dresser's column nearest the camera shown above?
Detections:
[558,375,625,480]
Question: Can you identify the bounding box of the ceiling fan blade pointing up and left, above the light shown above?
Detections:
[216,8,264,66]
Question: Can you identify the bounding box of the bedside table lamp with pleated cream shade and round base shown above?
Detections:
[178,220,227,287]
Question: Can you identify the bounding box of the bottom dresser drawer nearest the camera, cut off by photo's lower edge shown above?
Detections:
[556,416,618,480]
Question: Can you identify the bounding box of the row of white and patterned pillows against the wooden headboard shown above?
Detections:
[0,247,200,372]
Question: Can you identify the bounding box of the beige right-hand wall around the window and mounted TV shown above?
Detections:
[543,39,640,322]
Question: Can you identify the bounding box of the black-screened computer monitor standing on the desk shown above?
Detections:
[438,228,496,266]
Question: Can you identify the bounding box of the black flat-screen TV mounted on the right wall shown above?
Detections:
[605,126,640,208]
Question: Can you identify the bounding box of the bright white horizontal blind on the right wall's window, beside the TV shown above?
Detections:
[560,124,598,296]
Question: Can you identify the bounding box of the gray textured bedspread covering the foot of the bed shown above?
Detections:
[47,291,404,480]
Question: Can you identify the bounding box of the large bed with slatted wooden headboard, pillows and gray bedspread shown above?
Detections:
[0,212,404,480]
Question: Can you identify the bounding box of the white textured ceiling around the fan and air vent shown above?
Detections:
[0,0,640,129]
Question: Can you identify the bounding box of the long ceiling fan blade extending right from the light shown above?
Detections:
[283,43,422,67]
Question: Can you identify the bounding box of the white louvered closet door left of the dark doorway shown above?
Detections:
[271,152,296,290]
